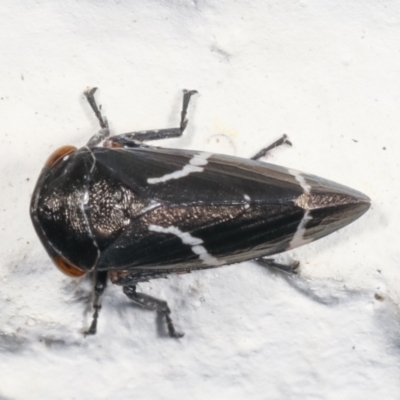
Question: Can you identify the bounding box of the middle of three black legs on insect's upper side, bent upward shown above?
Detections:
[104,90,197,147]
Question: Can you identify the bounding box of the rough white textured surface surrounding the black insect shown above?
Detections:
[0,0,400,400]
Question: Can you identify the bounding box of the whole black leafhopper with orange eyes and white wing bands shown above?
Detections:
[30,88,370,338]
